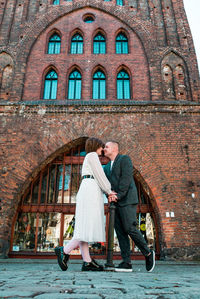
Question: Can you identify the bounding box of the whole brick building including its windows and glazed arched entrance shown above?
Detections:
[0,0,200,259]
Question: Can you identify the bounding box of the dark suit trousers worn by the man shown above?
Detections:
[115,204,150,263]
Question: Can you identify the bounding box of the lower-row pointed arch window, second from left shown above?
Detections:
[68,70,82,100]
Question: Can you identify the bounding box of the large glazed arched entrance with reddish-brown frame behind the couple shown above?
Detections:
[9,142,160,258]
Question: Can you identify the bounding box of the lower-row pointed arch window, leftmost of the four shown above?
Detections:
[43,70,58,100]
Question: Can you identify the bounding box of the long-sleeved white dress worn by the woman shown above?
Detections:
[73,152,111,242]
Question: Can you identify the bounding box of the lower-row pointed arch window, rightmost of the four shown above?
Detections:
[117,70,130,100]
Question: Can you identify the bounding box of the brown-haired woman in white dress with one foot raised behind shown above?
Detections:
[55,138,114,271]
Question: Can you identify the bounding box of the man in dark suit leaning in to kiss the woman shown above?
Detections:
[104,141,155,272]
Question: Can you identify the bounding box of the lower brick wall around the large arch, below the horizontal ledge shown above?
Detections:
[0,106,200,255]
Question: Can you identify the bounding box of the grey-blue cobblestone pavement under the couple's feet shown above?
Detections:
[0,259,200,299]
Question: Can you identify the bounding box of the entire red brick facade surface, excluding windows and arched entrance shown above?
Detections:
[0,0,200,258]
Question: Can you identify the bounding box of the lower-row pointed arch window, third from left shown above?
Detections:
[92,70,106,100]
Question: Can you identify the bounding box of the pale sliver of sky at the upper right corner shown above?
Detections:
[183,0,200,72]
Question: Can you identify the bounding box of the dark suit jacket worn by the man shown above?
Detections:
[104,155,138,206]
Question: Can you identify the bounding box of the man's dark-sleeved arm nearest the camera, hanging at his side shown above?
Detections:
[117,156,133,201]
